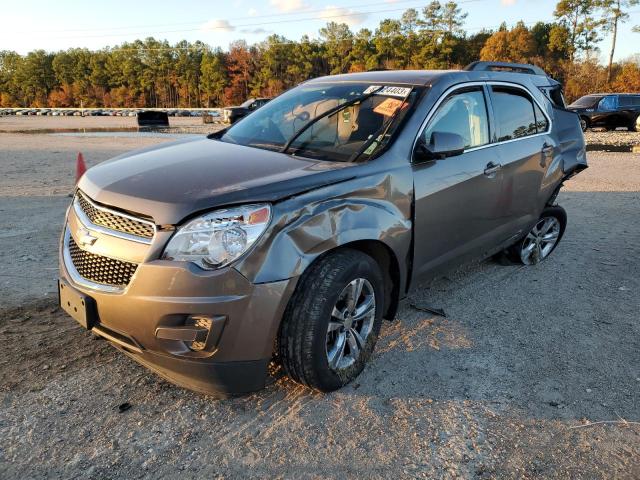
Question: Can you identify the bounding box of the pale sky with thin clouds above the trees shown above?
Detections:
[0,0,640,60]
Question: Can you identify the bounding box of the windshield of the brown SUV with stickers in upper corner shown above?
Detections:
[219,83,416,161]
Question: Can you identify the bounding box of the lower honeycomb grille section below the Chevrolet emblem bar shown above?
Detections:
[69,236,138,287]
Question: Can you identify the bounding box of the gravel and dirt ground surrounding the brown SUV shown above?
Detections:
[0,117,640,479]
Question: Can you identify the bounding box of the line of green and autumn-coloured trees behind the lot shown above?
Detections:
[0,0,640,108]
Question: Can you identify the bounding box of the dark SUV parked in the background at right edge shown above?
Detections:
[567,93,640,132]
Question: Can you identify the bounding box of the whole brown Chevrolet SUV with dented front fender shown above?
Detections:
[60,64,586,395]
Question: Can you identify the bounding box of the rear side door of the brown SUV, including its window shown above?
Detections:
[489,84,557,238]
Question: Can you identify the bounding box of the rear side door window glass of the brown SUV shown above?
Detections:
[491,86,548,142]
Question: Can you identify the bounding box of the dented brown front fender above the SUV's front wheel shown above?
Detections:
[236,176,412,283]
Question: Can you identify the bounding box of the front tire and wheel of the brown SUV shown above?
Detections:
[277,249,384,392]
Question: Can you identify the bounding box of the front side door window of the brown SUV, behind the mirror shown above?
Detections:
[422,87,489,148]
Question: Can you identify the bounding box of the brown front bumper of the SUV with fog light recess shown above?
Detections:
[60,238,297,396]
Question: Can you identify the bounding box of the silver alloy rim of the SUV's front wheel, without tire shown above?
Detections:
[326,278,376,372]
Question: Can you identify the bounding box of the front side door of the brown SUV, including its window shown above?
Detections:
[413,84,502,279]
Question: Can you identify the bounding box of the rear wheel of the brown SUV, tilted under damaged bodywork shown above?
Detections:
[506,205,567,265]
